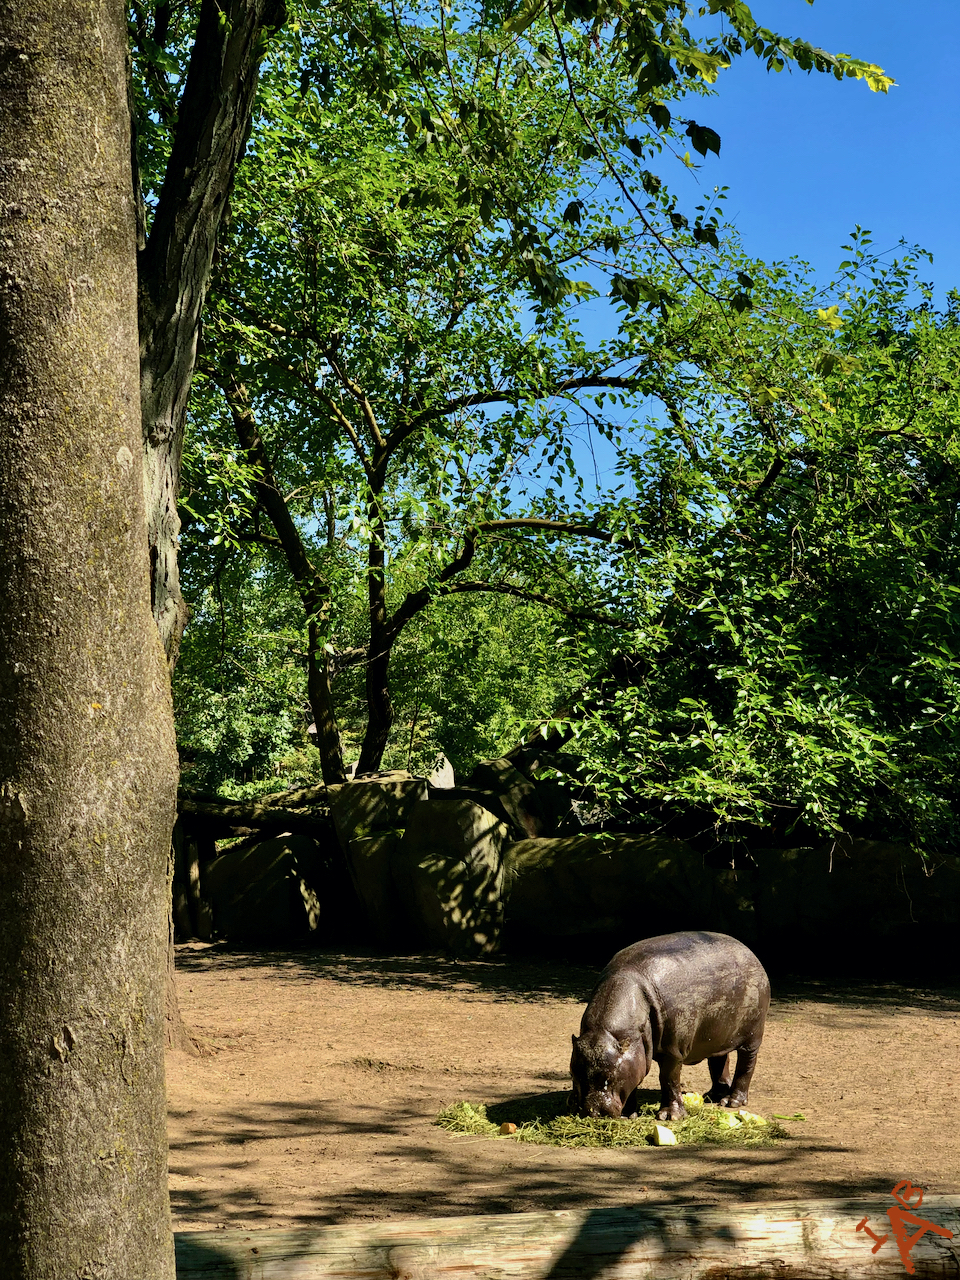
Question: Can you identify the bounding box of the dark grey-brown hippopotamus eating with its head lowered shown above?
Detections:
[570,932,771,1120]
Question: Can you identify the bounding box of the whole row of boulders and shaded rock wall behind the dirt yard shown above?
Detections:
[188,753,960,972]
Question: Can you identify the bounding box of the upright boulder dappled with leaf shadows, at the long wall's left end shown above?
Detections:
[393,791,508,956]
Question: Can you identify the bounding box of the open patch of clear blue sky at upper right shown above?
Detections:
[663,0,960,294]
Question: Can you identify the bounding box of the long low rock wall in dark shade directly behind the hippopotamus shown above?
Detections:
[503,836,960,972]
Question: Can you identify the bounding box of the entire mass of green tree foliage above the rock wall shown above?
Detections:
[141,3,957,846]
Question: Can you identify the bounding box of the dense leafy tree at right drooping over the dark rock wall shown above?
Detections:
[563,239,960,850]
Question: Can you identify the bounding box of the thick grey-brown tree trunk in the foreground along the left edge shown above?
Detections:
[0,0,177,1280]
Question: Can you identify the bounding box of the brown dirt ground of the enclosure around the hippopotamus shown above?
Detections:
[168,943,960,1230]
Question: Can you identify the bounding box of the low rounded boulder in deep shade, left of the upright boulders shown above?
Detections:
[201,836,329,946]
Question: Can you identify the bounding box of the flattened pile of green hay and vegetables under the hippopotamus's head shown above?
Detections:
[435,1093,788,1147]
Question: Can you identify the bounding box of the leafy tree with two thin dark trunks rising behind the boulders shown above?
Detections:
[175,2,896,782]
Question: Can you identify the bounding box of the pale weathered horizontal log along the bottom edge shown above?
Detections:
[177,1193,960,1280]
